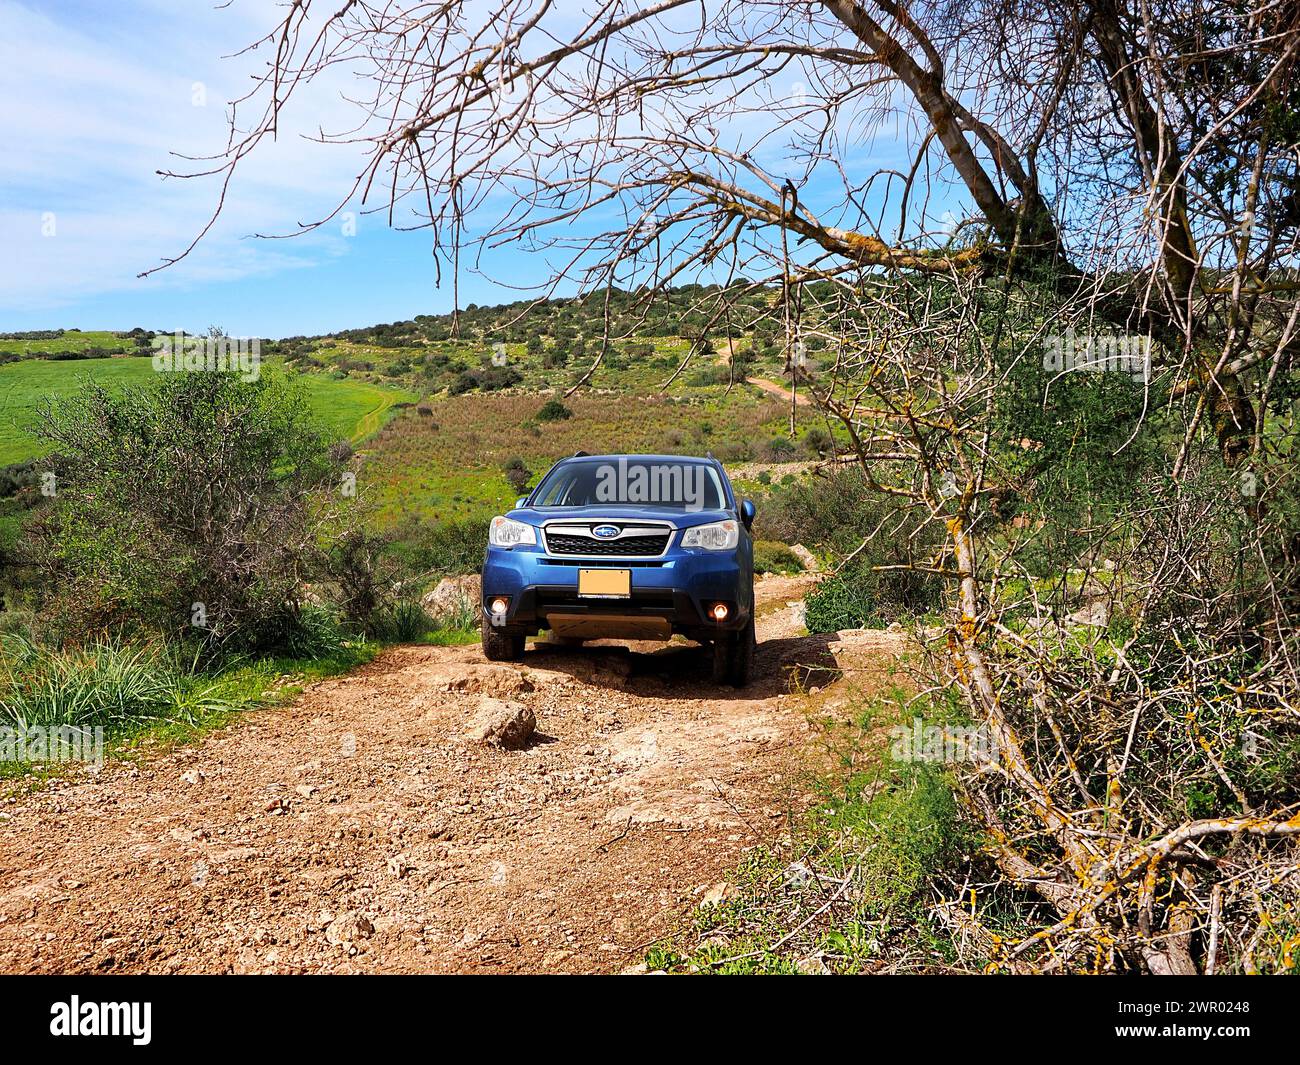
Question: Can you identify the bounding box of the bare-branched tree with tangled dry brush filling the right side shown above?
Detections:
[188,0,1300,974]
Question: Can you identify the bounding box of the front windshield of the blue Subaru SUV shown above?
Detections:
[532,458,727,511]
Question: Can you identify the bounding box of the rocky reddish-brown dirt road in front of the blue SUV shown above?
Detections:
[0,577,893,973]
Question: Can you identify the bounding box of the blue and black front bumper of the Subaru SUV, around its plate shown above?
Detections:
[482,547,754,637]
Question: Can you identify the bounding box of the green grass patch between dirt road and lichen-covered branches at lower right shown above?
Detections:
[646,688,974,974]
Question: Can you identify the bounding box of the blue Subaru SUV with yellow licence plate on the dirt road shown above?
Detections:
[482,451,757,688]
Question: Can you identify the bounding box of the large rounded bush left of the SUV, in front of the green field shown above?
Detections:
[29,372,338,651]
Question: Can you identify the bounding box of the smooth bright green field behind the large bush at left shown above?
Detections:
[0,358,415,466]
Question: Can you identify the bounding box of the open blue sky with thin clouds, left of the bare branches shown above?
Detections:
[0,0,935,337]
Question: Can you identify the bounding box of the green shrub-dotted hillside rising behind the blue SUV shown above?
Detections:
[0,286,827,527]
